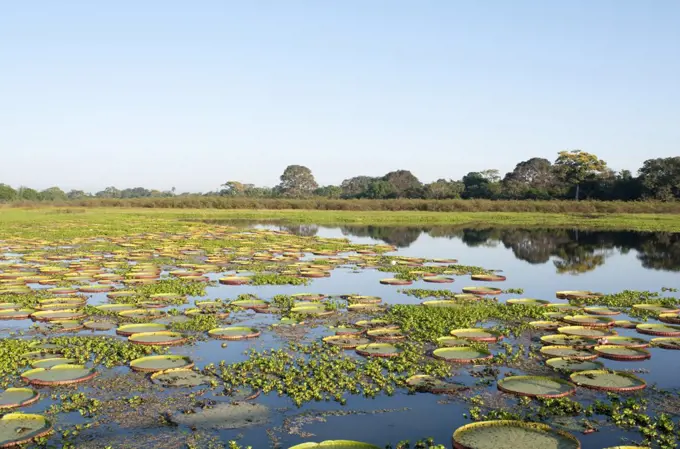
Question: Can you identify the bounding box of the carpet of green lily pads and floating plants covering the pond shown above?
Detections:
[0,221,680,449]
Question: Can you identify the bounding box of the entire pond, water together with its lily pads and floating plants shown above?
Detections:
[0,208,680,449]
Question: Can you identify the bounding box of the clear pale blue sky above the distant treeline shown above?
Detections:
[0,0,680,191]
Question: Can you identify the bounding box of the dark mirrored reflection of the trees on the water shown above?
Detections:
[198,220,680,274]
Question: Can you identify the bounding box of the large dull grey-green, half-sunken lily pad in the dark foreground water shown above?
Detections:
[172,402,269,430]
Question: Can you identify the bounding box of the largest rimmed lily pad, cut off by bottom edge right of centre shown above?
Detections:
[453,420,581,449]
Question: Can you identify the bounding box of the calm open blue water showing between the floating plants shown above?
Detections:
[5,224,680,449]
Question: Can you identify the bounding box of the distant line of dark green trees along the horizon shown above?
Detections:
[0,150,680,202]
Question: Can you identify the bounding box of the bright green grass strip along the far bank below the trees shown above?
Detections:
[0,207,680,233]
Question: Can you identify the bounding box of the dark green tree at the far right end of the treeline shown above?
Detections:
[639,156,680,201]
